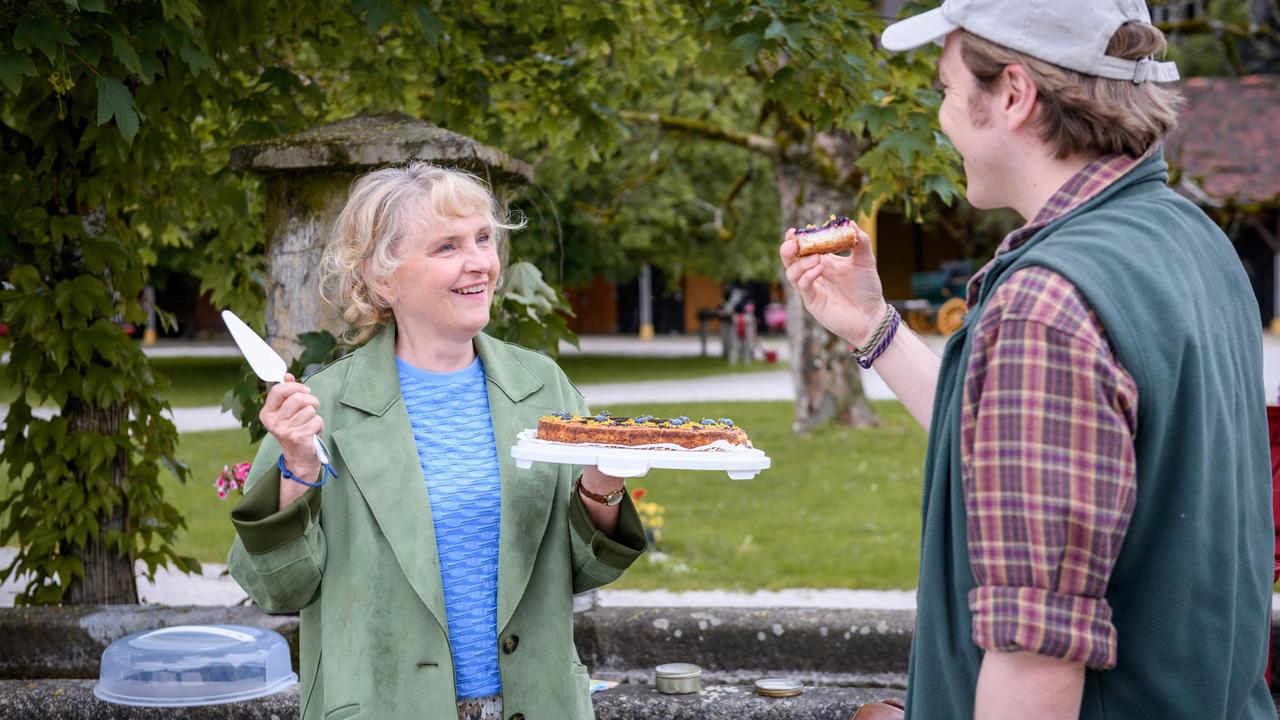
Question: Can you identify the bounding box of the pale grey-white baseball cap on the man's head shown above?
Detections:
[881,0,1178,85]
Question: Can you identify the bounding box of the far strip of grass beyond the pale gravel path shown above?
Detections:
[0,355,786,407]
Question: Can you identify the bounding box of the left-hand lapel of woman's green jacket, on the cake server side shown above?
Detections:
[333,324,448,632]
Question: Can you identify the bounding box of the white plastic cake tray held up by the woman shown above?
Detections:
[511,429,773,480]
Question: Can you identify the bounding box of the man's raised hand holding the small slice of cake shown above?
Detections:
[778,228,886,347]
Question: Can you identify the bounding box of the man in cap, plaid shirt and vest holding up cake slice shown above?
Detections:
[781,0,1276,720]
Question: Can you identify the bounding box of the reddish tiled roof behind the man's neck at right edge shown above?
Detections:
[1167,76,1280,205]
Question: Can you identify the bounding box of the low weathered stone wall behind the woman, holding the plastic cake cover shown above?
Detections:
[0,606,1280,720]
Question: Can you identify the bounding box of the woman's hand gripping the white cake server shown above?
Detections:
[257,374,324,510]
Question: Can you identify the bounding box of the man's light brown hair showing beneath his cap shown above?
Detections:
[960,22,1183,159]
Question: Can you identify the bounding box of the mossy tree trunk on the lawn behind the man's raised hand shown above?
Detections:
[774,128,878,433]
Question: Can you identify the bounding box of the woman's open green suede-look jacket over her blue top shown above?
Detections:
[228,325,645,720]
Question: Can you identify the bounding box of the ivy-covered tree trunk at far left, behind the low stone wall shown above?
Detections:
[63,405,138,605]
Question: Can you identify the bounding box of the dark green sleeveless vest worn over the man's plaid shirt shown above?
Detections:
[906,152,1276,720]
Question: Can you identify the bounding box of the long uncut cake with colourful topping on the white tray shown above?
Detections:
[538,411,751,450]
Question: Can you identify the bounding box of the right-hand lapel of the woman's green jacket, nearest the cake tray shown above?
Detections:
[476,333,558,632]
